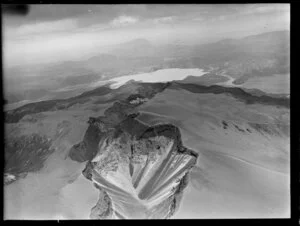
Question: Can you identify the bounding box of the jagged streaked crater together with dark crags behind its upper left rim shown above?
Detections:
[69,99,198,219]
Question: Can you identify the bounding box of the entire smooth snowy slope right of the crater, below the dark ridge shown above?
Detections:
[138,89,290,218]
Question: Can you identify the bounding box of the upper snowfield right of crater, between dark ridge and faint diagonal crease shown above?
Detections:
[138,89,290,172]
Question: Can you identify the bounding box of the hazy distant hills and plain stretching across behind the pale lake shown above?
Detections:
[4,31,290,107]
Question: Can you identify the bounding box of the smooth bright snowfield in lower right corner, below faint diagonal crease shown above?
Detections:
[179,149,290,218]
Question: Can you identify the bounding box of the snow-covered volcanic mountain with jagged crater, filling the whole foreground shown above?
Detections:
[4,81,290,219]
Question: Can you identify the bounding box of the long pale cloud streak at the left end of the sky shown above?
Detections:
[4,19,77,37]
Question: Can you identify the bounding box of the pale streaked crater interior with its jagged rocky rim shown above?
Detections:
[83,119,198,219]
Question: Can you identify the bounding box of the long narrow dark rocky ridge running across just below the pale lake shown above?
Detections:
[5,79,290,123]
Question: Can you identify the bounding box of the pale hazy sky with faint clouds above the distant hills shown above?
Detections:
[2,4,290,67]
